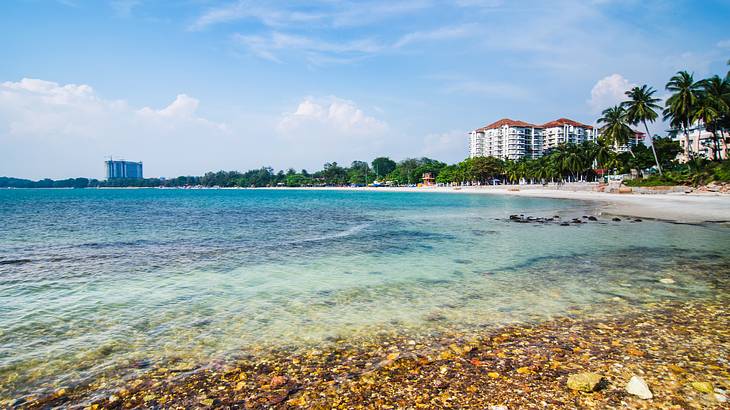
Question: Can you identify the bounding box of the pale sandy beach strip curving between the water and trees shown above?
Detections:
[267,184,730,223]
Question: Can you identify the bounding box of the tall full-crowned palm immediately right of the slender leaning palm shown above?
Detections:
[664,71,700,159]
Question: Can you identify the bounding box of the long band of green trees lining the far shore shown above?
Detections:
[0,138,681,188]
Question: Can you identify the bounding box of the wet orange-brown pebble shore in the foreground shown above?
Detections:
[24,296,730,409]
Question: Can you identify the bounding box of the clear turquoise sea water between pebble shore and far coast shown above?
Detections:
[0,189,730,398]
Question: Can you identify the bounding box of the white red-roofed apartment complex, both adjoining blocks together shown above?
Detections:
[469,118,596,160]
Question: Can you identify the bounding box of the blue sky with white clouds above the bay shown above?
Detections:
[0,0,730,179]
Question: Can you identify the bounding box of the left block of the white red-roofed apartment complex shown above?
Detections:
[469,118,542,160]
